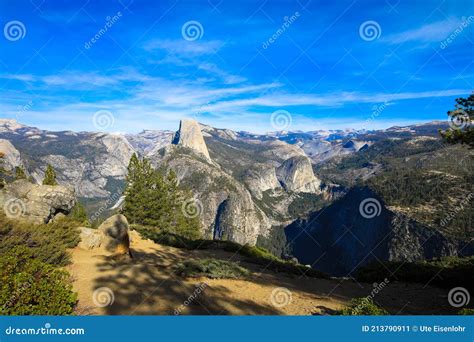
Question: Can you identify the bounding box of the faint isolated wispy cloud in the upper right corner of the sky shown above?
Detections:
[382,17,461,44]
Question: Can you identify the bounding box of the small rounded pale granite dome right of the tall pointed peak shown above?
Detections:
[277,156,321,193]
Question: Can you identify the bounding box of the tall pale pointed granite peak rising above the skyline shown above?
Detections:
[173,119,211,161]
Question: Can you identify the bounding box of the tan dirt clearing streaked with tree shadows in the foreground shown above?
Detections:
[68,234,454,315]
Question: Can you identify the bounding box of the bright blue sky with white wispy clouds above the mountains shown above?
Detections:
[0,0,474,132]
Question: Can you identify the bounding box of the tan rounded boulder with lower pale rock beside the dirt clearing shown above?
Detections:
[79,215,130,255]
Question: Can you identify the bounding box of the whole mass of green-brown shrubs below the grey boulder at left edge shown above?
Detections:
[0,213,79,315]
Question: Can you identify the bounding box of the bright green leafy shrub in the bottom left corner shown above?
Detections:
[0,246,77,315]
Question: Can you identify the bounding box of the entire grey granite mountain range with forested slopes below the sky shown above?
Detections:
[0,119,474,275]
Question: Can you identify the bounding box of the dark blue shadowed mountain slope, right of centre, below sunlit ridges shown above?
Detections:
[285,188,474,276]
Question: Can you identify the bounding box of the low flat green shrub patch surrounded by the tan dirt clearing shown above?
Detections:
[176,259,250,279]
